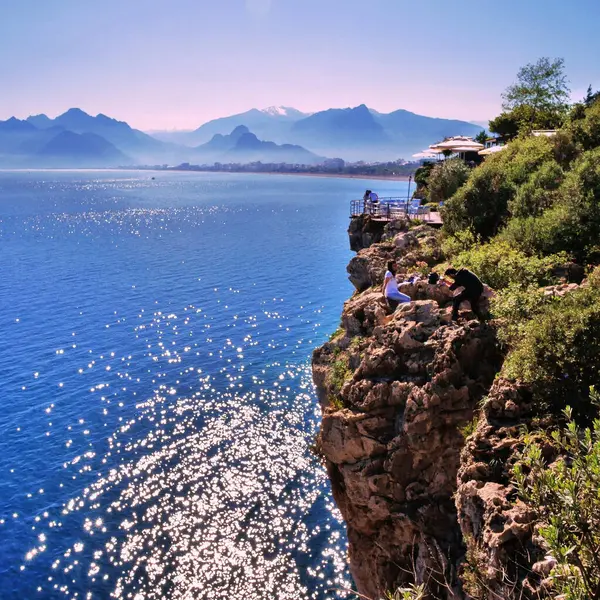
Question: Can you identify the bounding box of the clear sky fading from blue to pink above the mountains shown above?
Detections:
[0,0,600,130]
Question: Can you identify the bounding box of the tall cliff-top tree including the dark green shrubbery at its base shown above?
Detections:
[490,57,570,138]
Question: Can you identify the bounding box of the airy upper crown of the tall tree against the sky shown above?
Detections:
[502,57,570,113]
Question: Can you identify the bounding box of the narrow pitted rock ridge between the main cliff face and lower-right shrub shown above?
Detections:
[456,379,549,600]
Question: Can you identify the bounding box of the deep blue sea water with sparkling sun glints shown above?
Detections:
[0,171,407,600]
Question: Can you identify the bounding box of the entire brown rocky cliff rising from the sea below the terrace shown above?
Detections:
[313,222,572,600]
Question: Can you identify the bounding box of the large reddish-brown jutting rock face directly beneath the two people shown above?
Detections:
[313,286,500,598]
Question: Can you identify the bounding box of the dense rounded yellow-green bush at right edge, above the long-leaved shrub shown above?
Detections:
[503,268,600,411]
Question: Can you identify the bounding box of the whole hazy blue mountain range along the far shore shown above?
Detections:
[0,104,488,168]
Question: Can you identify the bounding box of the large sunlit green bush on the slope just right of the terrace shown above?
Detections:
[442,137,554,239]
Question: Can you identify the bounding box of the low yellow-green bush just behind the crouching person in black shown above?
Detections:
[452,240,567,290]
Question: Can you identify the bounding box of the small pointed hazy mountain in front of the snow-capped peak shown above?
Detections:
[194,125,324,164]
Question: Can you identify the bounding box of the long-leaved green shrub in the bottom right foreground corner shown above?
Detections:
[514,389,600,600]
